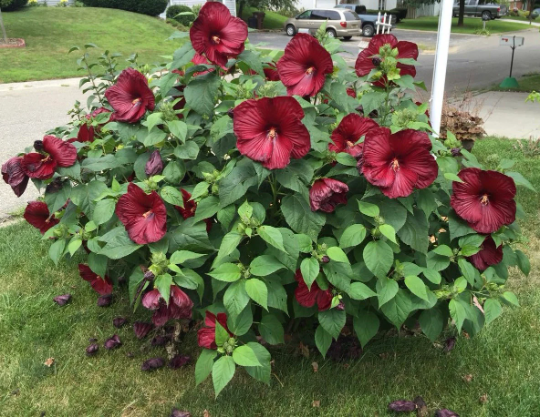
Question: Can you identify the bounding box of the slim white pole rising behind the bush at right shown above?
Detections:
[430,0,454,135]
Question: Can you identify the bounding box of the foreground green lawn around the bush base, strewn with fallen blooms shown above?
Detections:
[0,139,540,417]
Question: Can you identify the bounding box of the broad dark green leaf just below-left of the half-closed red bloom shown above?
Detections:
[281,194,326,241]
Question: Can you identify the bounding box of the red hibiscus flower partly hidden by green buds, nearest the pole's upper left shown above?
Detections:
[354,35,418,87]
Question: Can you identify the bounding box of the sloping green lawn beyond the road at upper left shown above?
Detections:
[0,7,178,83]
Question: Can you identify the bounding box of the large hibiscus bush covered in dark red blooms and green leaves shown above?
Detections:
[2,2,531,395]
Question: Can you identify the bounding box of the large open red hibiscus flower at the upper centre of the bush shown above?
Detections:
[233,97,311,169]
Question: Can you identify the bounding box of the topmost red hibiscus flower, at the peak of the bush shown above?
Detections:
[189,2,248,69]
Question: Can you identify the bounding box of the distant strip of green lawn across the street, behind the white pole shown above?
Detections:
[397,17,527,34]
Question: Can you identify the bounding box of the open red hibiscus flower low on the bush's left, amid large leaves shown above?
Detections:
[116,183,167,245]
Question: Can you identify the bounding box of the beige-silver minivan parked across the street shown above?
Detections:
[283,9,362,40]
